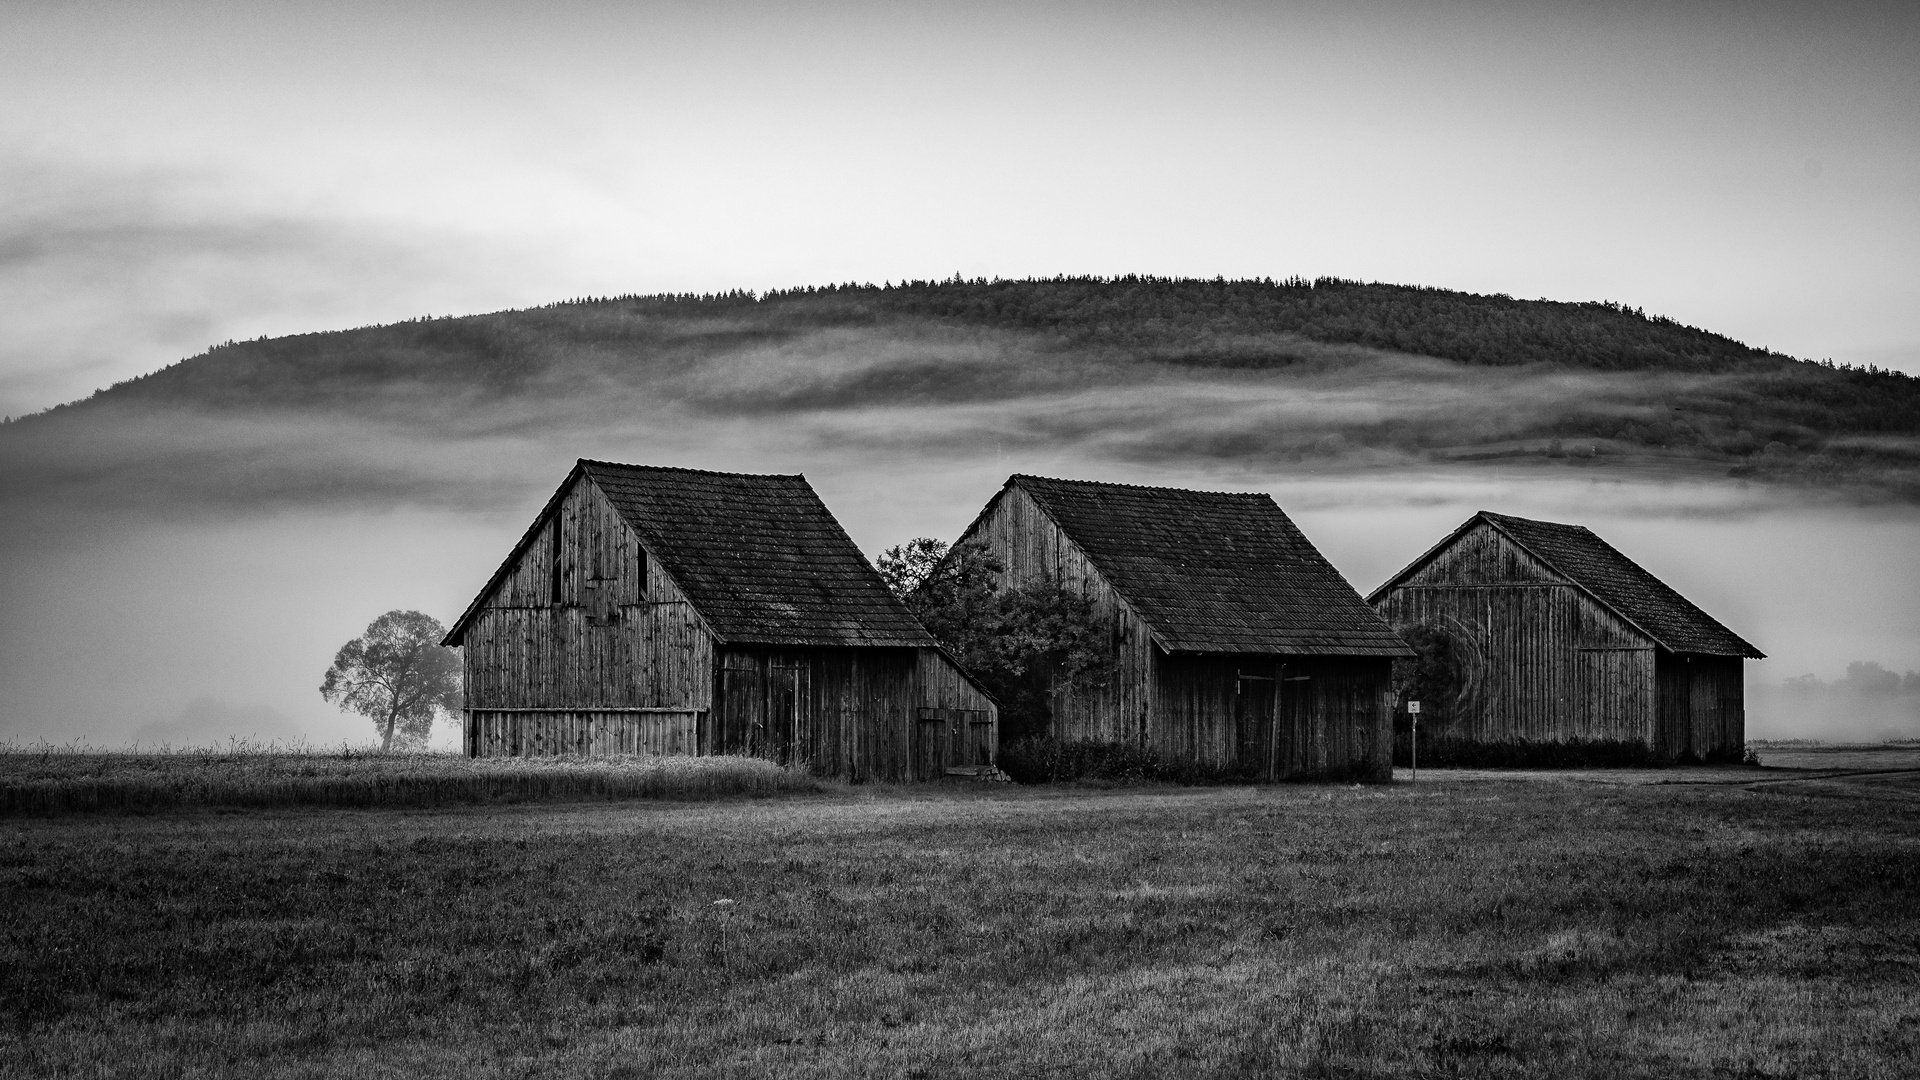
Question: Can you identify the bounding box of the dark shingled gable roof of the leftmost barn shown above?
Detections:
[447,459,935,648]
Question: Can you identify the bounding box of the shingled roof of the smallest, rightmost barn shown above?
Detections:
[1375,509,1766,659]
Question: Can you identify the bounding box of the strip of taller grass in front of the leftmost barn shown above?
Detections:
[0,742,822,817]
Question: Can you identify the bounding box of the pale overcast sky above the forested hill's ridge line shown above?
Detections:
[0,0,1920,415]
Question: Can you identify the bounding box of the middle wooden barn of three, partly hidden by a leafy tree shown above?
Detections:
[960,475,1411,780]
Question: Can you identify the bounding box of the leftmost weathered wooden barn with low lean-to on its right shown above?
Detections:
[445,461,998,780]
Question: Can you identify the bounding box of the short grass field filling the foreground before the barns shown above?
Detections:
[0,757,1920,1080]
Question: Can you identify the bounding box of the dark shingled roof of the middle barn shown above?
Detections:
[1002,475,1413,655]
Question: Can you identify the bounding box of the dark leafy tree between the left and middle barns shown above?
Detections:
[879,536,1116,742]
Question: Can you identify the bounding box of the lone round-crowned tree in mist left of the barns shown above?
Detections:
[321,611,461,753]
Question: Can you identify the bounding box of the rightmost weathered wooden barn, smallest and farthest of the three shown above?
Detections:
[1367,511,1763,759]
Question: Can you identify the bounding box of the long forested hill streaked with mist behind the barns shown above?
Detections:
[6,277,1920,500]
